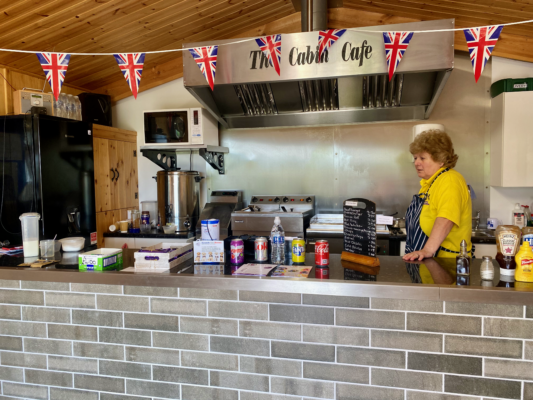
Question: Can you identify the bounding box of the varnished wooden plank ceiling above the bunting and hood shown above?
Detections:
[4,0,533,101]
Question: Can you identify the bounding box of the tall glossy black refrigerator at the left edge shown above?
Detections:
[0,114,96,245]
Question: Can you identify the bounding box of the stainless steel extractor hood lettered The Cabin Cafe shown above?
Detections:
[183,19,454,128]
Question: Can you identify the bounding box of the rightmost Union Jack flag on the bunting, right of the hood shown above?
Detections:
[463,25,503,82]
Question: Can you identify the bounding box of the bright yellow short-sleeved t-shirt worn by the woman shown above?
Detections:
[419,168,472,257]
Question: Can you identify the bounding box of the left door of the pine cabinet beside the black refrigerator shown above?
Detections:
[93,138,113,212]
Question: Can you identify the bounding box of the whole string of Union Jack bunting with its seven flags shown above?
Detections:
[6,16,533,96]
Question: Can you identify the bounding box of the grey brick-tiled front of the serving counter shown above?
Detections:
[0,280,533,400]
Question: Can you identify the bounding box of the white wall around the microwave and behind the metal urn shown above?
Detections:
[113,78,206,206]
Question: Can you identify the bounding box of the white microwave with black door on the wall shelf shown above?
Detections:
[141,108,218,147]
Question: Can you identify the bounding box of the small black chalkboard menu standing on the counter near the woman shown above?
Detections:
[343,199,376,257]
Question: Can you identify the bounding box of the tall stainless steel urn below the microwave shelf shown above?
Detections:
[156,170,202,232]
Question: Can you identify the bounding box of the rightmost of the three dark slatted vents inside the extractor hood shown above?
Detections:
[363,74,403,109]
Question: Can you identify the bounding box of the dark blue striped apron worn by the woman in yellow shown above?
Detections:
[405,168,459,257]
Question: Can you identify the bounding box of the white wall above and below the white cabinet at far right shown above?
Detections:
[490,57,533,224]
